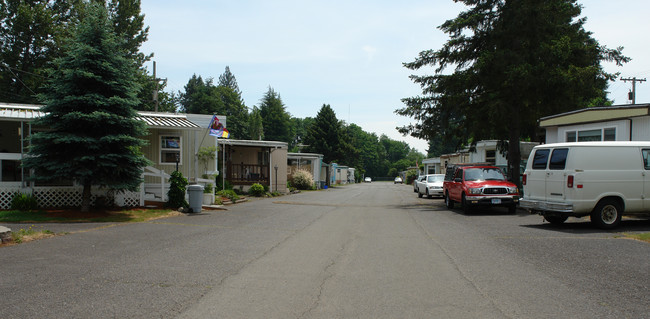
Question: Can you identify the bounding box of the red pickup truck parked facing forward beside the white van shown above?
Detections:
[442,164,519,214]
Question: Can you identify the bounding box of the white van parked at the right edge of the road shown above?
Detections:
[519,142,650,229]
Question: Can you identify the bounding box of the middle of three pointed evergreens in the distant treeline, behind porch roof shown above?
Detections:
[259,87,293,143]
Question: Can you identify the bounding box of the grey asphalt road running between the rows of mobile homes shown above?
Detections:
[0,182,650,318]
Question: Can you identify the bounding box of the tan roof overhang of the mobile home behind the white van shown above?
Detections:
[539,104,650,128]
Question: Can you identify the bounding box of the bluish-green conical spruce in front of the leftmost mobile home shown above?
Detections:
[23,5,149,211]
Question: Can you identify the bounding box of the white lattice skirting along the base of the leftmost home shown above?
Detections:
[0,187,140,209]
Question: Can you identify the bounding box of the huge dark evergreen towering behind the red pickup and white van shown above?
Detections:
[396,0,629,183]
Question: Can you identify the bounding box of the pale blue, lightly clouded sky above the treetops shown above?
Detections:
[142,0,650,154]
